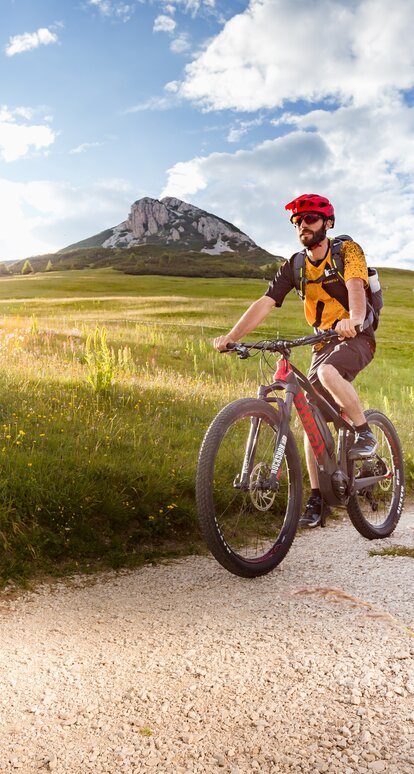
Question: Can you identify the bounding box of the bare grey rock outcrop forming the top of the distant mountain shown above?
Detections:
[61,196,260,255]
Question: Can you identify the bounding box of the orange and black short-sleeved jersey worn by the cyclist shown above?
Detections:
[265,240,376,331]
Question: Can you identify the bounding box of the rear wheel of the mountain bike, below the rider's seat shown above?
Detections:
[347,410,405,540]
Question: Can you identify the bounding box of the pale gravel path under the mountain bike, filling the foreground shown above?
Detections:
[0,509,414,774]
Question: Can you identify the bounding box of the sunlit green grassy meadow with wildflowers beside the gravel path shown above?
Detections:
[0,269,414,582]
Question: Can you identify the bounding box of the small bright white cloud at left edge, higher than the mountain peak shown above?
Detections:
[0,107,56,162]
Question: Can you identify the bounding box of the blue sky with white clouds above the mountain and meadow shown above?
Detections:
[0,0,414,270]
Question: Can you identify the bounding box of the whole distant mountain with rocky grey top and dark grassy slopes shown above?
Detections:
[7,197,283,277]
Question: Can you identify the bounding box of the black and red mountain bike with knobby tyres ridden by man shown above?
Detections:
[196,330,405,578]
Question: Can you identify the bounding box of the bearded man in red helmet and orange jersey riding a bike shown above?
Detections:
[214,194,377,527]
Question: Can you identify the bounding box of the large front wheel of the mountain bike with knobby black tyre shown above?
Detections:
[196,398,302,578]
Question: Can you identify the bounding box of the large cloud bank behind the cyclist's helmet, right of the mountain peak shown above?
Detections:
[161,98,414,269]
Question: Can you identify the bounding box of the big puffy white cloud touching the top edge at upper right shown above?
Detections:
[181,0,414,111]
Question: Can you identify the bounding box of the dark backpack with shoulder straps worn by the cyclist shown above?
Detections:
[292,234,384,330]
